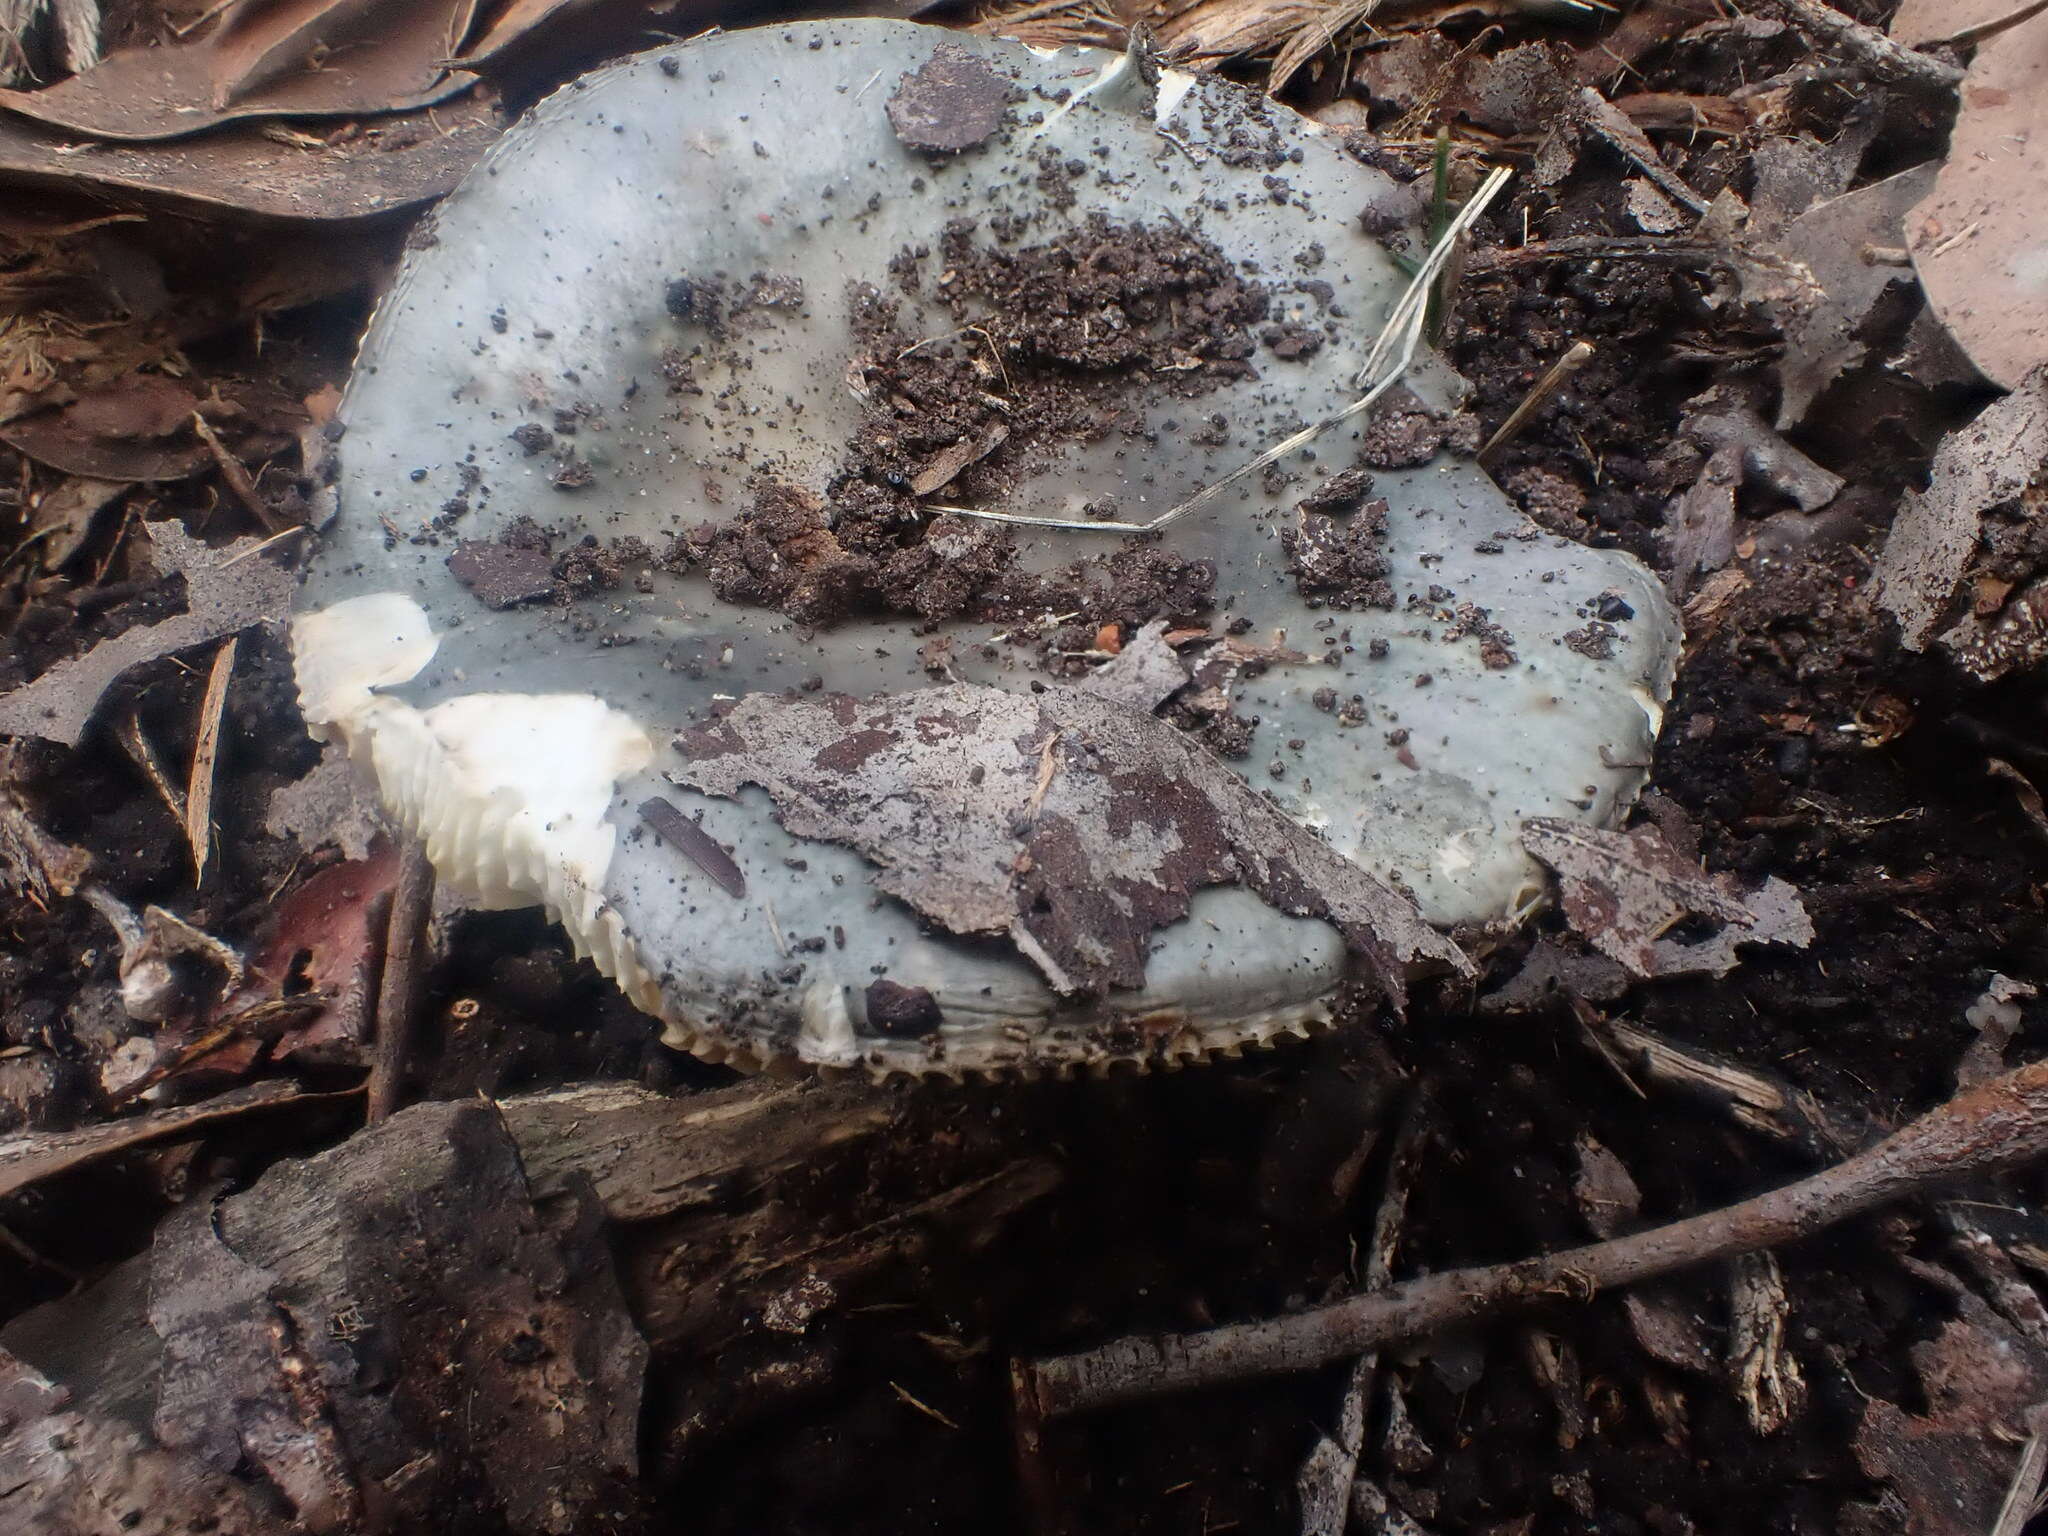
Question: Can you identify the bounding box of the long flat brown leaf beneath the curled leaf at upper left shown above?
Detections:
[0,90,504,219]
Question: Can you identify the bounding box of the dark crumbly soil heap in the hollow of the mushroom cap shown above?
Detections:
[663,214,1286,627]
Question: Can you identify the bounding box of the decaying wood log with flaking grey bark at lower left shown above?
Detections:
[0,1081,1059,1536]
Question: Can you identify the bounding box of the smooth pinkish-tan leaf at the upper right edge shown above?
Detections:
[1907,14,2048,389]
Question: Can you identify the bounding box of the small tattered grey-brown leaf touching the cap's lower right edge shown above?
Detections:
[1522,817,1812,979]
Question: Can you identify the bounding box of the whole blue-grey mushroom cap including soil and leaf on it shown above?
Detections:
[295,20,1677,1075]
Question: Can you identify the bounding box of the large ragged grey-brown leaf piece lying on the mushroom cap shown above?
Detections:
[672,684,1470,1004]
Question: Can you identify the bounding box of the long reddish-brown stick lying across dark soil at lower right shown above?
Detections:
[1014,1061,2048,1419]
